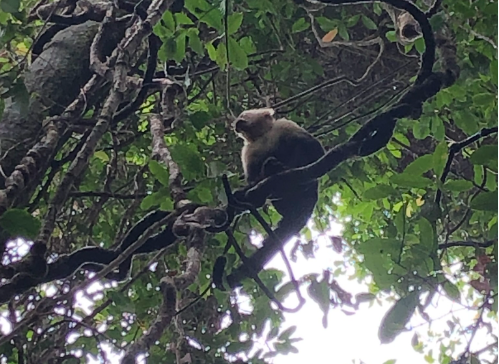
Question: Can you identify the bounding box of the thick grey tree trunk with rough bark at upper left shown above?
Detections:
[0,21,123,188]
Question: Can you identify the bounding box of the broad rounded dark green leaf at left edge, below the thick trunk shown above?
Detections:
[0,209,41,239]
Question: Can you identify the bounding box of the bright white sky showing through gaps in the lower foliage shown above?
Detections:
[0,223,497,364]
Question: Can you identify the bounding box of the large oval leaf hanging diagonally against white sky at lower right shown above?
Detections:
[378,292,419,344]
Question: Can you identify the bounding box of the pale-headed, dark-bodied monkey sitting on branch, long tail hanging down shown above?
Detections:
[218,108,325,288]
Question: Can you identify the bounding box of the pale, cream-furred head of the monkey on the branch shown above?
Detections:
[232,108,275,142]
